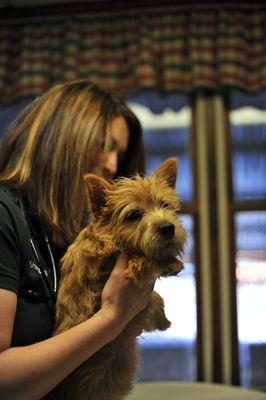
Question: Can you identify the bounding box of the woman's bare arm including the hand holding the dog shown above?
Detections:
[0,256,154,400]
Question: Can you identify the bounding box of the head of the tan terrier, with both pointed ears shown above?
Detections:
[85,158,185,275]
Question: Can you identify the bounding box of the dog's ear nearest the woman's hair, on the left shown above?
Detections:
[84,174,113,219]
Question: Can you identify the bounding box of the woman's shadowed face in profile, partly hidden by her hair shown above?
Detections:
[93,117,129,179]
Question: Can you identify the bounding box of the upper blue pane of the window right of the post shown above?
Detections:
[230,107,266,200]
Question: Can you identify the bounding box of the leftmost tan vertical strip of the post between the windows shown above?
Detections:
[194,93,214,382]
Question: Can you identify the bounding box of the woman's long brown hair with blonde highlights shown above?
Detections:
[0,80,144,246]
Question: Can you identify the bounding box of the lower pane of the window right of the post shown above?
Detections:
[235,212,266,388]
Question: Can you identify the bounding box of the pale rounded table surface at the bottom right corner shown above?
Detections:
[126,382,266,400]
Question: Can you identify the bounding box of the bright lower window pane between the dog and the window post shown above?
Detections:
[138,215,197,381]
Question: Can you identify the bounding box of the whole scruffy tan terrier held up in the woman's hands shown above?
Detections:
[47,159,185,400]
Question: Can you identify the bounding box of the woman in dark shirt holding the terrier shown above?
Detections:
[0,80,153,400]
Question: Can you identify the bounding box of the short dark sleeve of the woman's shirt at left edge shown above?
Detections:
[0,203,21,293]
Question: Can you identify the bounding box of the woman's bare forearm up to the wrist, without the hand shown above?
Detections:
[0,311,123,400]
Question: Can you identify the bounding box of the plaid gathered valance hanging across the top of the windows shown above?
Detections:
[0,5,266,104]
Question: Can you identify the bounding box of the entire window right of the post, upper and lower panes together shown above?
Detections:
[230,107,266,388]
